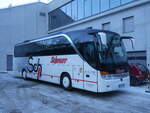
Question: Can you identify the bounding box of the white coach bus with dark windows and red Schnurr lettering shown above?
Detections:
[14,29,130,92]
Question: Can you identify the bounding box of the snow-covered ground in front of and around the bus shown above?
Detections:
[0,74,150,113]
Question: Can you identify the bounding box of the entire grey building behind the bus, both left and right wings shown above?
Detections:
[0,0,150,71]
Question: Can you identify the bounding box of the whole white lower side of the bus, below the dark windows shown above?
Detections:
[15,55,84,89]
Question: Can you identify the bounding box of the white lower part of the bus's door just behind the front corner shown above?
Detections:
[84,62,98,92]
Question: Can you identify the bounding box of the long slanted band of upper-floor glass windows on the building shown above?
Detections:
[48,0,136,30]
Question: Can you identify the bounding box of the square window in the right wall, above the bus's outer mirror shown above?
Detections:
[123,16,134,33]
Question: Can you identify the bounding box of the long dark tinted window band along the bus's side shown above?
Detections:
[15,37,76,57]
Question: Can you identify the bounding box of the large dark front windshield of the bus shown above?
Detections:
[97,32,127,73]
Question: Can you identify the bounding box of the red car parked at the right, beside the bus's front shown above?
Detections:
[129,63,150,86]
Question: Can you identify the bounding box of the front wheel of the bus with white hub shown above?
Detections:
[60,73,72,90]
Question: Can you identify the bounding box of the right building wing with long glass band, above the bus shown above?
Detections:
[48,0,150,69]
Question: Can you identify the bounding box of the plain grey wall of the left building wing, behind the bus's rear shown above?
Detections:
[0,3,48,71]
